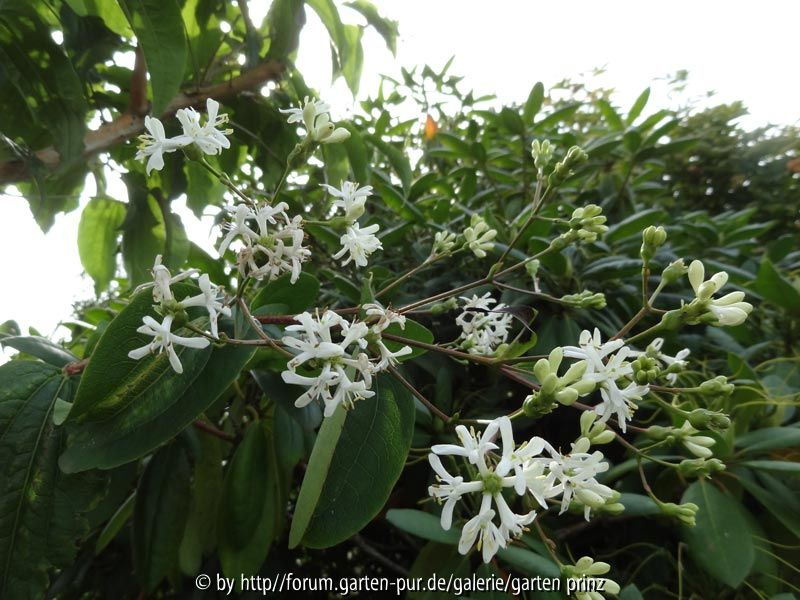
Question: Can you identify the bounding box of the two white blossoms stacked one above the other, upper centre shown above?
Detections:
[322,181,383,267]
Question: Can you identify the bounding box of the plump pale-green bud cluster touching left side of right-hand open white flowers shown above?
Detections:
[522,348,597,417]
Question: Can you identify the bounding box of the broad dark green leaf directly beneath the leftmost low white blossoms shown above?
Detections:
[60,308,255,472]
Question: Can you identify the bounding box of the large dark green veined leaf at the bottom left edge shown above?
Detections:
[0,360,103,600]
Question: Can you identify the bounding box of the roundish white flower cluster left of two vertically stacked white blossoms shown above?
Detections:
[219,202,311,283]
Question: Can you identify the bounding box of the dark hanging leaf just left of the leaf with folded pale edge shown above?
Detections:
[217,423,282,579]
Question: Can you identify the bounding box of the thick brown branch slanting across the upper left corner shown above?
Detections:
[0,60,284,185]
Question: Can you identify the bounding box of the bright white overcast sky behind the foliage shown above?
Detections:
[0,0,800,362]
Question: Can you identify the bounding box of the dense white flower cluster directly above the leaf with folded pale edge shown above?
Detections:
[281,304,411,417]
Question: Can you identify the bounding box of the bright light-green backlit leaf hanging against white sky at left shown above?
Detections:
[78,198,126,295]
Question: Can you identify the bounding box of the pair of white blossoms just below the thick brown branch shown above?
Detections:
[136,98,233,175]
